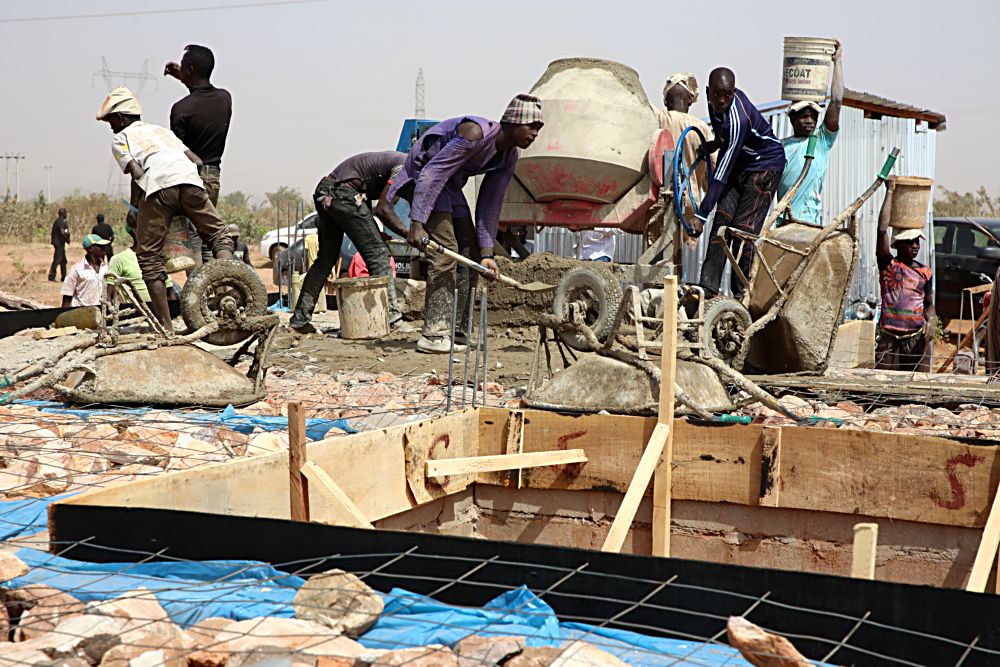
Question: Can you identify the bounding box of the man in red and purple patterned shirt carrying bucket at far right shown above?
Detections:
[875,182,936,371]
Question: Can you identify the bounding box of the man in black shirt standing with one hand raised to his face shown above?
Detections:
[163,44,233,261]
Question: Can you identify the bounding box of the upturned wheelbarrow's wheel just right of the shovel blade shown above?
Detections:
[552,266,622,352]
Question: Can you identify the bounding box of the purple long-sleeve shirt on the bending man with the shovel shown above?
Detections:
[388,116,518,248]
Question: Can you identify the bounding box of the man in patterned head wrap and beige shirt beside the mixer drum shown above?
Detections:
[648,72,715,242]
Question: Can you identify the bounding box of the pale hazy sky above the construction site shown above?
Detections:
[0,0,1000,206]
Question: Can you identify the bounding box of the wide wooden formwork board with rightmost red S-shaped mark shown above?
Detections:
[777,427,1000,526]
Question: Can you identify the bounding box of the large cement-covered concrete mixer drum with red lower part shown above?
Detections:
[517,58,659,204]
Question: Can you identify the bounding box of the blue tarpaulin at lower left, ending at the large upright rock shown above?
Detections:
[6,549,305,627]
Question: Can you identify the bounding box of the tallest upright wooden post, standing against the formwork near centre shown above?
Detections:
[652,276,677,557]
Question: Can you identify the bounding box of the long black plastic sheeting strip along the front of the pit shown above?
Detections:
[49,504,1000,666]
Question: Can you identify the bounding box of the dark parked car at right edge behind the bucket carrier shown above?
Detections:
[934,218,1000,319]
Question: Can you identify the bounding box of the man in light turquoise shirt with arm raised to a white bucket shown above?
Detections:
[778,41,844,226]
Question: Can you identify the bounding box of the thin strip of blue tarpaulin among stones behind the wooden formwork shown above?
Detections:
[15,401,357,440]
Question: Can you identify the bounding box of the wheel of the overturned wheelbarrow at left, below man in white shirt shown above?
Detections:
[180,259,267,345]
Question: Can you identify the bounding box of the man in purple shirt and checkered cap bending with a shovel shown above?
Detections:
[387,94,542,353]
